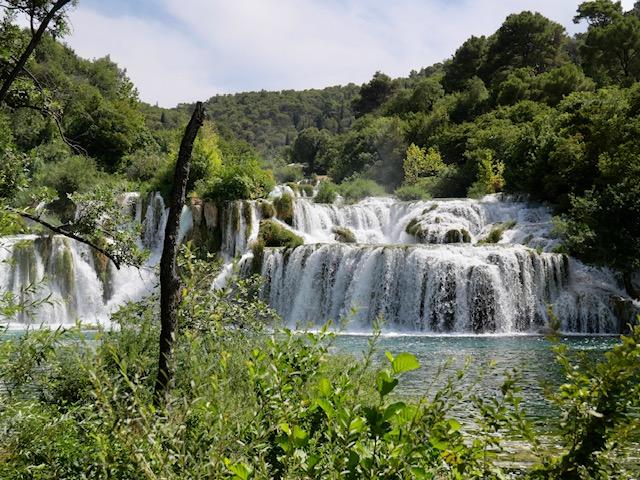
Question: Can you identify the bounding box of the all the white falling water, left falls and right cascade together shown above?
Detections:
[0,186,637,334]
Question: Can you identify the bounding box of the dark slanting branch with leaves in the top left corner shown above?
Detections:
[0,0,77,105]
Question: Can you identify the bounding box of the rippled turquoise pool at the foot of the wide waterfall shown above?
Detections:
[334,335,619,425]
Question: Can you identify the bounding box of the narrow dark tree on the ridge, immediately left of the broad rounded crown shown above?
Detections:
[442,36,488,92]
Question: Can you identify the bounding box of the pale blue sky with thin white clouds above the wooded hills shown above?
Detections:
[65,0,634,107]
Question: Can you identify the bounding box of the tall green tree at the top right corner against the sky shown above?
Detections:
[573,0,640,84]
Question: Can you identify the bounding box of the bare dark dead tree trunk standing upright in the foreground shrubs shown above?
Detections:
[154,102,204,405]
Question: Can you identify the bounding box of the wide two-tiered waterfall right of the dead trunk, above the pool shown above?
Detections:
[262,195,638,333]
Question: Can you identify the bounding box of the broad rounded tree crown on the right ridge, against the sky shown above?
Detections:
[485,11,566,79]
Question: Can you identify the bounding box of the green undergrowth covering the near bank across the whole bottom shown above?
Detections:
[0,264,640,479]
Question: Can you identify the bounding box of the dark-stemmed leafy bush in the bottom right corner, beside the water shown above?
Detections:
[532,318,640,480]
